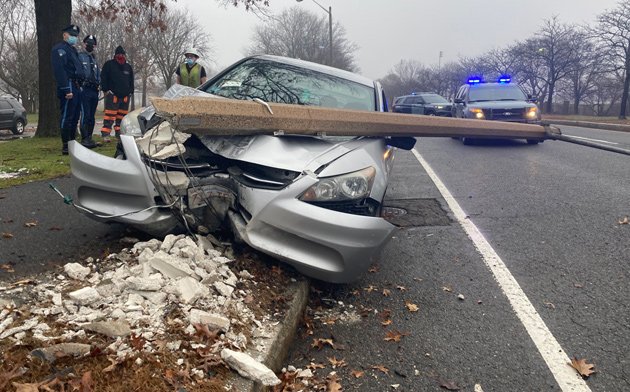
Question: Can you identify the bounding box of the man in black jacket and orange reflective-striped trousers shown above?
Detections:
[101,46,133,142]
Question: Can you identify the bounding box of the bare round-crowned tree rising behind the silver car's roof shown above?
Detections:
[247,6,358,71]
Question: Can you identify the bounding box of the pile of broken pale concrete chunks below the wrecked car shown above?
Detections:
[0,235,280,385]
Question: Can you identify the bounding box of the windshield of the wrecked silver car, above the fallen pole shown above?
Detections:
[205,59,376,111]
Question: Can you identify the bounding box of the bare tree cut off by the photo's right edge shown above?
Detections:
[593,0,630,119]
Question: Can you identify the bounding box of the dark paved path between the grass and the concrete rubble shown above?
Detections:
[0,176,131,281]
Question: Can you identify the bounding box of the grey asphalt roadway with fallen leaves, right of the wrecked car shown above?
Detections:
[287,127,630,391]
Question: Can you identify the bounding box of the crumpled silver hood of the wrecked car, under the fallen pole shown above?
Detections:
[145,84,358,172]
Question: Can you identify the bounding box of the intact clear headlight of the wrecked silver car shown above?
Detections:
[298,166,376,202]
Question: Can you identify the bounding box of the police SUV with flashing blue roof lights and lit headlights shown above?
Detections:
[453,76,543,144]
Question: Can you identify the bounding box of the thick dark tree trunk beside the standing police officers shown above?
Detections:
[35,0,72,136]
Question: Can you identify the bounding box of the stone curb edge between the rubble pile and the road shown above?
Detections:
[228,280,310,392]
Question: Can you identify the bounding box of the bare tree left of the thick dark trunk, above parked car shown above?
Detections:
[0,2,38,113]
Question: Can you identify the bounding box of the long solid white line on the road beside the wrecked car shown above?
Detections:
[412,150,590,392]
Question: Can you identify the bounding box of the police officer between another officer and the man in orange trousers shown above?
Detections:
[79,35,101,148]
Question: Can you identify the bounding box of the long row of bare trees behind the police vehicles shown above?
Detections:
[381,0,630,119]
